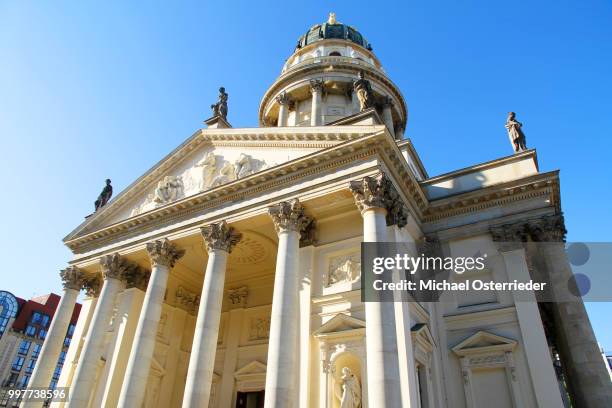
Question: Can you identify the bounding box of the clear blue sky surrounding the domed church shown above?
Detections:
[0,0,612,351]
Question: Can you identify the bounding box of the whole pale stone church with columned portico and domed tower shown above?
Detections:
[19,13,612,408]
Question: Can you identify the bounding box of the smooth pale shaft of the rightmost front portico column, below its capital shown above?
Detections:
[363,207,402,408]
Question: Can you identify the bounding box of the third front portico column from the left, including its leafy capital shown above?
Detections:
[118,239,185,408]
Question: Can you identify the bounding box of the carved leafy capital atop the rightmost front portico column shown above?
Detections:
[349,172,409,228]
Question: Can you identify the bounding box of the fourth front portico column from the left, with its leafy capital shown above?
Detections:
[183,221,242,408]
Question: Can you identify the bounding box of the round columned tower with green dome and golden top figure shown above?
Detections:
[259,13,407,139]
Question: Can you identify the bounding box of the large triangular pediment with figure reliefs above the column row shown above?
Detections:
[64,125,380,241]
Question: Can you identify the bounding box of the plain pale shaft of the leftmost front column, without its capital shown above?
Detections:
[26,288,79,406]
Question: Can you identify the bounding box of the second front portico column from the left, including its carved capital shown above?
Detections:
[66,253,132,408]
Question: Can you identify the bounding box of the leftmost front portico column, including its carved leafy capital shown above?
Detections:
[21,266,85,407]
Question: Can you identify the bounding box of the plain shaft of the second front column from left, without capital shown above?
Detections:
[66,278,125,408]
